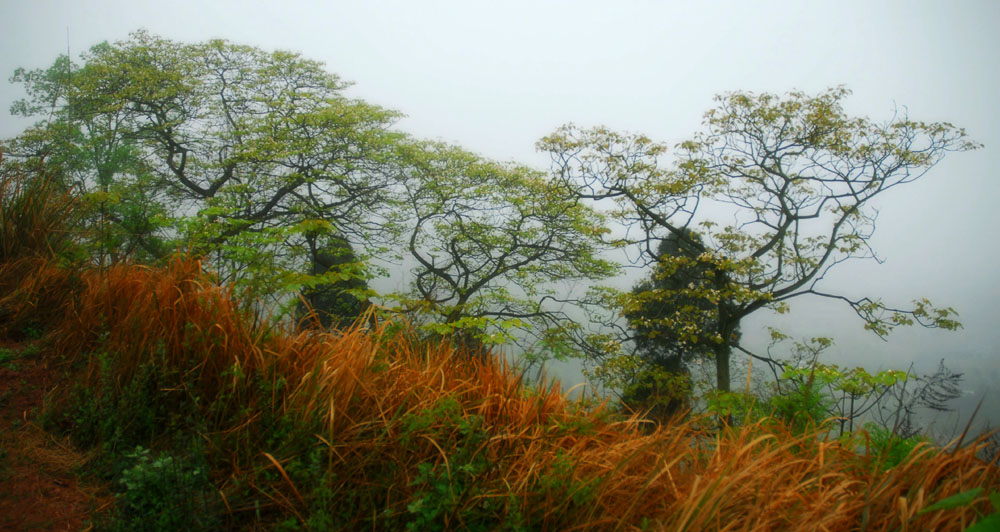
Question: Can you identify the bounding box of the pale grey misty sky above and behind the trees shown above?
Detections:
[0,0,1000,432]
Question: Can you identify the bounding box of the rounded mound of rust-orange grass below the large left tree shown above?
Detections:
[55,257,264,397]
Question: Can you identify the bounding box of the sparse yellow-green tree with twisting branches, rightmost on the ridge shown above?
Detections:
[539,88,978,391]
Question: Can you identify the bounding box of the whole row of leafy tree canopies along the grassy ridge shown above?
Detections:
[2,31,978,400]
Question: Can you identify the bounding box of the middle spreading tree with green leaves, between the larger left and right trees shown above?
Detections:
[396,142,616,358]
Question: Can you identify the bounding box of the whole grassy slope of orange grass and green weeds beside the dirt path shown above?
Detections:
[0,161,1000,531]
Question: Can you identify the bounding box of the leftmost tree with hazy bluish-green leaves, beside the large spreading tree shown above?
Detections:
[4,50,165,262]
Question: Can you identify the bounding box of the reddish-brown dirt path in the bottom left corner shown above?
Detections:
[0,340,111,532]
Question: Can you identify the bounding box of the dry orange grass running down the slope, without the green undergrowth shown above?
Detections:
[39,259,998,530]
